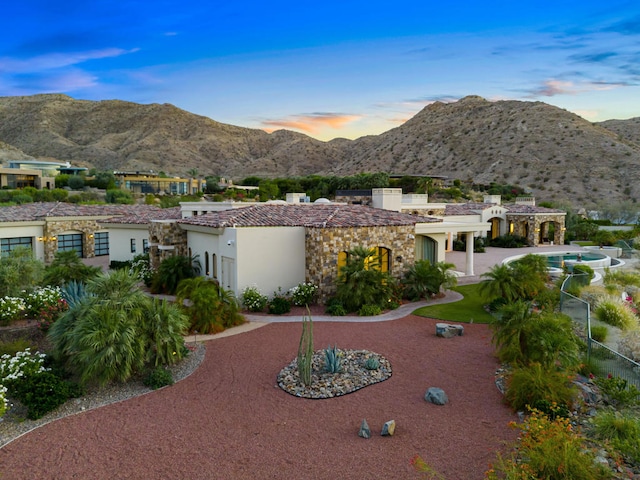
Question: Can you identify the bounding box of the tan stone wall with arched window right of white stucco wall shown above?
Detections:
[305,225,415,302]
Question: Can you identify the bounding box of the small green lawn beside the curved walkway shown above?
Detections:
[413,283,493,323]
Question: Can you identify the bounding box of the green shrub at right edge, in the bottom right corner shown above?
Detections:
[593,409,640,464]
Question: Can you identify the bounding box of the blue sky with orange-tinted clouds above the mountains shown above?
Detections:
[0,0,640,140]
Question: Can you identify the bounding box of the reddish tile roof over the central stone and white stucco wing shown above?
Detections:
[179,204,442,228]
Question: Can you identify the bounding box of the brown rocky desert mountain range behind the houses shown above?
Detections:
[0,94,640,205]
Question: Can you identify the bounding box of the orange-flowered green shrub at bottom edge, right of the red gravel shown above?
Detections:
[485,410,611,480]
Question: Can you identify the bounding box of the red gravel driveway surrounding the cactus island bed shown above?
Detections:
[0,315,515,480]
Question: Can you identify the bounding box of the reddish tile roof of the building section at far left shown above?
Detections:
[0,202,170,222]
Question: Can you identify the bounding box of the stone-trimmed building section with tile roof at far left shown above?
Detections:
[0,202,168,264]
